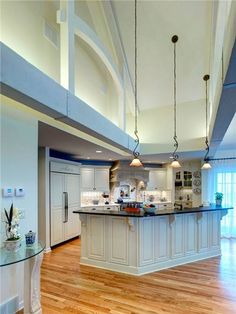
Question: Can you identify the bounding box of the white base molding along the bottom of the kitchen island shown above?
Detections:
[80,250,221,276]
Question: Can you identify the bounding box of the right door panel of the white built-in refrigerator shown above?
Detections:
[64,174,81,240]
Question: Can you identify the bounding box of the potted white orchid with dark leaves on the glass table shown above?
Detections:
[4,204,21,252]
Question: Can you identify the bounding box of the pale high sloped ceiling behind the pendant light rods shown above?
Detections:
[112,0,212,110]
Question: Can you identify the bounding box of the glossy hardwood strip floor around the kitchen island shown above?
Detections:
[41,240,236,314]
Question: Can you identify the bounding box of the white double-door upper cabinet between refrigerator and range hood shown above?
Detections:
[81,167,109,192]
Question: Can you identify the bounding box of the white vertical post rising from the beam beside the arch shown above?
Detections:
[57,0,75,94]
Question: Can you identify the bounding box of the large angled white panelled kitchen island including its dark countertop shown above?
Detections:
[74,206,232,275]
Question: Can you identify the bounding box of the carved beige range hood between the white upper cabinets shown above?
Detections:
[110,160,149,183]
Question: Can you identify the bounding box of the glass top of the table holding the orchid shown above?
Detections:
[0,241,45,267]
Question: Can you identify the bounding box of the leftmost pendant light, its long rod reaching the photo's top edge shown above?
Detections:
[130,0,142,167]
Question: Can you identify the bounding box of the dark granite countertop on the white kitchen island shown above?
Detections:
[73,205,233,218]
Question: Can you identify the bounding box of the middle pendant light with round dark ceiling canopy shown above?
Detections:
[170,35,181,168]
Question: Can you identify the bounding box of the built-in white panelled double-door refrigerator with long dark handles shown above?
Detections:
[50,163,81,246]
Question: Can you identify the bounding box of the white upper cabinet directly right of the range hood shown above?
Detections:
[147,169,167,191]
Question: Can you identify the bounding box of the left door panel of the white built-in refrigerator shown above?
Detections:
[50,172,65,245]
